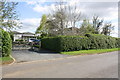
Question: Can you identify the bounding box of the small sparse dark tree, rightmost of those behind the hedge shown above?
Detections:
[101,23,114,36]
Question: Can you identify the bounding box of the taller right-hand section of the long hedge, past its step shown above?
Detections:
[85,34,116,49]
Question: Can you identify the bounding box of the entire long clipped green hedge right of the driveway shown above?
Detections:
[41,34,120,52]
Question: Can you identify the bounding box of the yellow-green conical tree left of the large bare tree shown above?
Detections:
[35,14,47,34]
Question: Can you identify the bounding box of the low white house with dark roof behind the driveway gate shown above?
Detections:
[13,31,37,42]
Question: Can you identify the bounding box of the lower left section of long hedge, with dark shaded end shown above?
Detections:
[41,36,90,52]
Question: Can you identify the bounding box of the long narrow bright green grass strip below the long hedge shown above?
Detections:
[61,48,120,55]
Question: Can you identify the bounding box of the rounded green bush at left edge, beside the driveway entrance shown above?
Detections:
[0,29,12,57]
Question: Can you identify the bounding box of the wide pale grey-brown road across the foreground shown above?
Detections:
[2,51,118,78]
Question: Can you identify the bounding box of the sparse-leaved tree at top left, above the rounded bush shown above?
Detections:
[0,0,21,31]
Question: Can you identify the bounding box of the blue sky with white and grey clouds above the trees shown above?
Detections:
[12,0,118,37]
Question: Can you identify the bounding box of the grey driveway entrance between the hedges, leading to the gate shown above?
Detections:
[12,50,69,63]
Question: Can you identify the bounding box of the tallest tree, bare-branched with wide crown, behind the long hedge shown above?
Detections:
[46,1,81,35]
